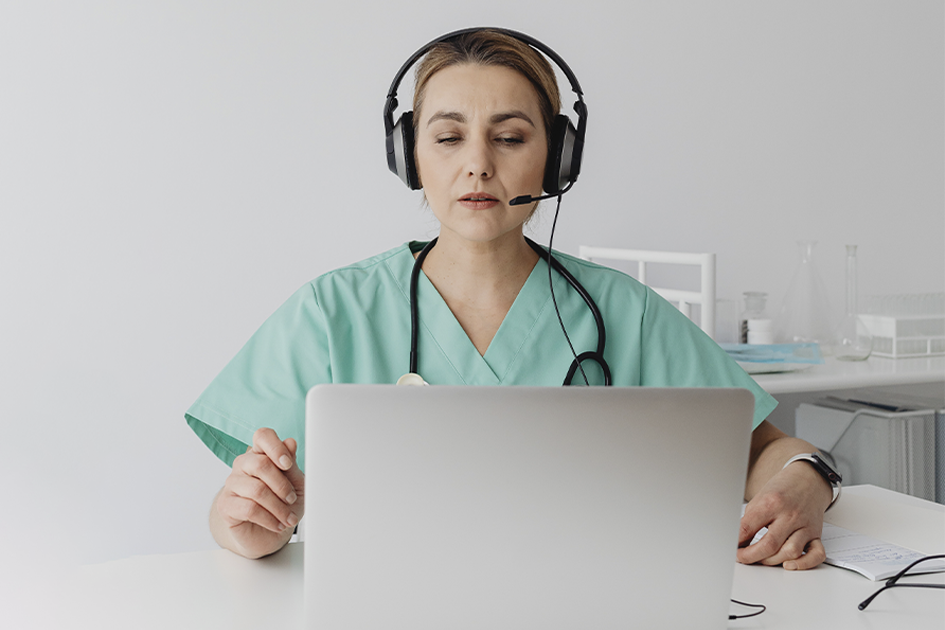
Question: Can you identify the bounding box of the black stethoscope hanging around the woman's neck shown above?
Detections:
[398,237,611,385]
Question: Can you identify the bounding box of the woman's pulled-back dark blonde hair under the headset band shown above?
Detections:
[413,29,561,138]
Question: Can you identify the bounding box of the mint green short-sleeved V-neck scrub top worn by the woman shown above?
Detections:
[185,242,777,466]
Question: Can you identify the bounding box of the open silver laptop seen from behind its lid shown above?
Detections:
[304,385,754,630]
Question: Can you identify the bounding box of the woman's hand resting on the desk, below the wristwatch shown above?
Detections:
[736,461,833,571]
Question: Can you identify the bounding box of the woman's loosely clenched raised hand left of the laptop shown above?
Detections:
[210,428,305,558]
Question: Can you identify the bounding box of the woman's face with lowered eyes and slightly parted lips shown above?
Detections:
[416,64,548,243]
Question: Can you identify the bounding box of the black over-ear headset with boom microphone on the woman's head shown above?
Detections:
[384,28,587,198]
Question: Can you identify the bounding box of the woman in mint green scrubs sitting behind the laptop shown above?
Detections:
[186,30,833,569]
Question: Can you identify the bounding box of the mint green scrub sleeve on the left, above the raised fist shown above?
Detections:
[184,284,331,466]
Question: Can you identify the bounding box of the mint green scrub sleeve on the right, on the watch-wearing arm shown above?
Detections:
[640,287,778,429]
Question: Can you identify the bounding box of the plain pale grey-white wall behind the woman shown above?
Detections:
[0,0,945,566]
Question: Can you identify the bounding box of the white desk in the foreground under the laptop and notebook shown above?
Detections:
[22,486,945,630]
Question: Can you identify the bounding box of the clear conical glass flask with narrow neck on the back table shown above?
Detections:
[775,241,834,355]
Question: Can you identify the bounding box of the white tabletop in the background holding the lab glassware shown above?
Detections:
[754,357,945,394]
